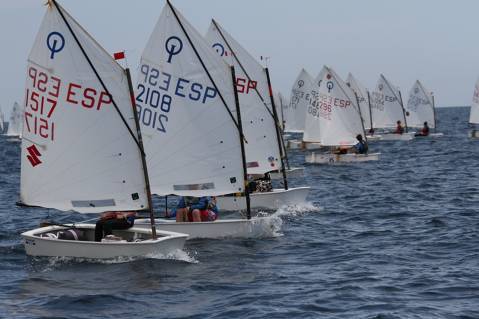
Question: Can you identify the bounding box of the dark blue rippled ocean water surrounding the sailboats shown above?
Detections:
[0,108,479,319]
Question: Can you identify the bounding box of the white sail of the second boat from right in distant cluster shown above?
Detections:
[371,74,406,128]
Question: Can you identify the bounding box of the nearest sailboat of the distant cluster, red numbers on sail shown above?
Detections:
[305,66,379,164]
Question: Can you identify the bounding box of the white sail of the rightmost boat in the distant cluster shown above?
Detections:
[406,80,435,128]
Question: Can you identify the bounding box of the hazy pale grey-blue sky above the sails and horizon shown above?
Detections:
[0,0,479,113]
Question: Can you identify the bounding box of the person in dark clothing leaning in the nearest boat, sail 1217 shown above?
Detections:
[95,212,136,241]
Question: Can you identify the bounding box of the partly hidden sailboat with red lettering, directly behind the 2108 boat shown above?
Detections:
[206,20,309,210]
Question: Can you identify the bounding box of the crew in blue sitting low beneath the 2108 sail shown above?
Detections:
[176,196,218,223]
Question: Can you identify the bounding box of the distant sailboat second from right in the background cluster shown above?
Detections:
[371,74,414,141]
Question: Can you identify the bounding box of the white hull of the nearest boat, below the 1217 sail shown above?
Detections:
[21,224,188,259]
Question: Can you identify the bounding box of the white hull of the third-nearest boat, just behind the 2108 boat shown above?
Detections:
[216,187,310,211]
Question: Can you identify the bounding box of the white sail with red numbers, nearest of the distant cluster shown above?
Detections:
[310,66,364,146]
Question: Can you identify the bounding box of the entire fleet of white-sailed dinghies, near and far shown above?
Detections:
[0,0,479,259]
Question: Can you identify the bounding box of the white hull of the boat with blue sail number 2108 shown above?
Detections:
[135,217,279,239]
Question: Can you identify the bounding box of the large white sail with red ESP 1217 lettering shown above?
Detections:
[20,5,148,213]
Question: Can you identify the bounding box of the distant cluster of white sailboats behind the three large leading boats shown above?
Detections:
[283,66,443,164]
